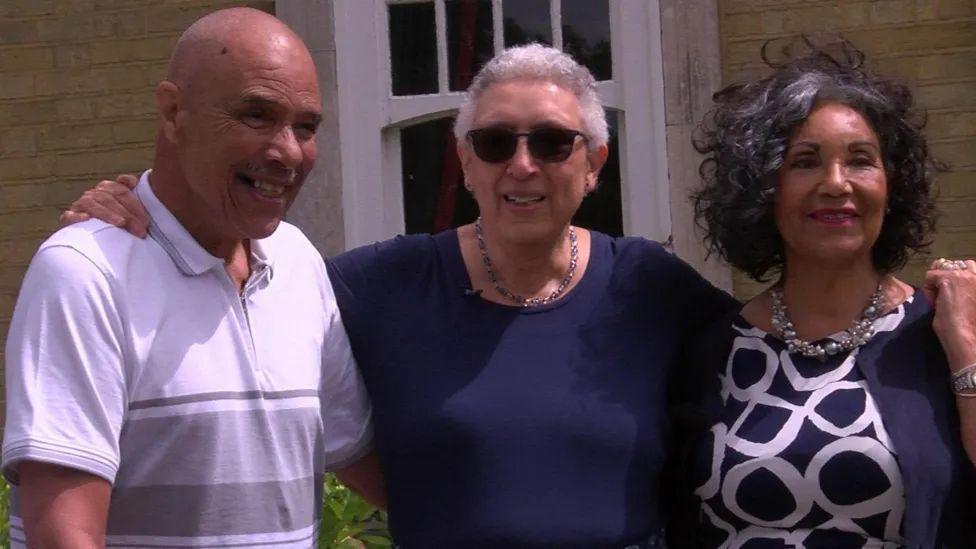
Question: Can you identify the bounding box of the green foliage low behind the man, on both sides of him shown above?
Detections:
[0,475,392,549]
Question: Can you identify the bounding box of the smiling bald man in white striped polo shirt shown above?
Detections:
[2,9,382,549]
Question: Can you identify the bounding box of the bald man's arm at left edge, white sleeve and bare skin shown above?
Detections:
[3,245,126,548]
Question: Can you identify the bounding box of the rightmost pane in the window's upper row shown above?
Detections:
[562,0,613,80]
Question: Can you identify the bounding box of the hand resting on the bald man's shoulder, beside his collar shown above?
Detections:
[59,174,149,238]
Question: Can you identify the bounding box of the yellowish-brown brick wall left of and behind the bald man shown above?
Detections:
[0,0,274,413]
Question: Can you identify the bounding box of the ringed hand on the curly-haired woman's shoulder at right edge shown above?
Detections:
[922,259,976,372]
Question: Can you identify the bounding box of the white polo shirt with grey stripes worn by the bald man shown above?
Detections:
[3,172,371,548]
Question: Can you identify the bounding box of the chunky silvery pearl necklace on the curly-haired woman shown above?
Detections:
[769,282,884,361]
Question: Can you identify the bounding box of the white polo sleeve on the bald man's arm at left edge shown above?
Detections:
[2,246,127,484]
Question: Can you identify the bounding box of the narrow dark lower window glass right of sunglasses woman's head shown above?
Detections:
[573,110,624,236]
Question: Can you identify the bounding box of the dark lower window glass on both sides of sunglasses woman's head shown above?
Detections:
[400,111,623,236]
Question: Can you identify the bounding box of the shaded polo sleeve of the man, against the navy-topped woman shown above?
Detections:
[320,270,373,471]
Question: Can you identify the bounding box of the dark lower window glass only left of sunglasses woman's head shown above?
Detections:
[400,118,478,234]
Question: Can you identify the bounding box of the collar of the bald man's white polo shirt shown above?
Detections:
[134,170,274,276]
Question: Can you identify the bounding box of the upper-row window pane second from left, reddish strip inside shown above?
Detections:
[445,0,495,91]
